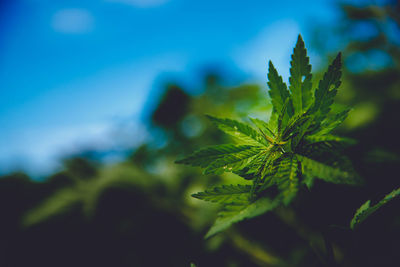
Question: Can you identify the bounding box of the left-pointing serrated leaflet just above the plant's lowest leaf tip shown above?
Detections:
[192,184,251,203]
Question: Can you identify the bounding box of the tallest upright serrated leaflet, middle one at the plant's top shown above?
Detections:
[289,35,312,114]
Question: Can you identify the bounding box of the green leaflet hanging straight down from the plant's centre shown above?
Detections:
[273,155,299,205]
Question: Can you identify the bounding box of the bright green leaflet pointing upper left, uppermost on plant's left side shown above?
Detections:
[207,115,267,146]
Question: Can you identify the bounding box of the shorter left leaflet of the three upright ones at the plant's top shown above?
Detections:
[268,61,293,117]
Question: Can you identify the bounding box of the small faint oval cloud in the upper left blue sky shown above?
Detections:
[51,8,94,33]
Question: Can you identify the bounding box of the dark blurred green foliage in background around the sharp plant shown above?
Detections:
[0,1,400,267]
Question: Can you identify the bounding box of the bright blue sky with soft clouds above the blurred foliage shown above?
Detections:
[0,0,337,176]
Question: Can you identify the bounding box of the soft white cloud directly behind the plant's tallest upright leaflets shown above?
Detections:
[233,20,300,82]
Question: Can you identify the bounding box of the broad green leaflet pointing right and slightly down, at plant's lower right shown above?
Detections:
[297,155,360,185]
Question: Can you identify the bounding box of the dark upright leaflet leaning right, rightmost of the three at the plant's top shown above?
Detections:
[310,53,342,121]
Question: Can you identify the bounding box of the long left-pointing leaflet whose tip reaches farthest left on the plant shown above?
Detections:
[176,144,260,168]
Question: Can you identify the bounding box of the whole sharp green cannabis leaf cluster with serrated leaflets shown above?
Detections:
[177,35,360,237]
